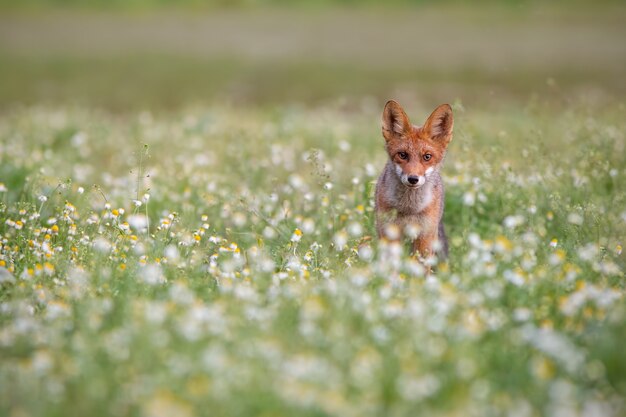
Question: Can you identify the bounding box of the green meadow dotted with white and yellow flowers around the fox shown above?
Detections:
[0,3,626,417]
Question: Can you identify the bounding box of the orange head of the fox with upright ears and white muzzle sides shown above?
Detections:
[383,100,454,188]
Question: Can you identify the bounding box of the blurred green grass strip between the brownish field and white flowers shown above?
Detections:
[0,54,626,113]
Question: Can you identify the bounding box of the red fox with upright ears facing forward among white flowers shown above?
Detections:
[376,100,454,259]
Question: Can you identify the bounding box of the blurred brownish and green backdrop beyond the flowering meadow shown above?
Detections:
[0,0,626,112]
